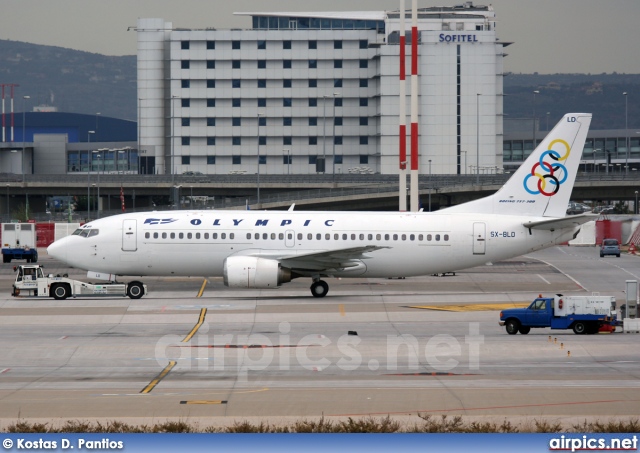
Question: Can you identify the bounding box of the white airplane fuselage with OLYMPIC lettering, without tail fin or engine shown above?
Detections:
[49,211,578,277]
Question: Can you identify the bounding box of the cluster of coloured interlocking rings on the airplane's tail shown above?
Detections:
[524,139,571,197]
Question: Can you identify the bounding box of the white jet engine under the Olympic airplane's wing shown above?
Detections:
[223,256,291,289]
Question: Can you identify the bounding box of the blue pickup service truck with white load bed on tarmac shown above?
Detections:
[499,294,618,335]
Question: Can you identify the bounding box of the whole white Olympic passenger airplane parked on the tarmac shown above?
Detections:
[47,113,593,297]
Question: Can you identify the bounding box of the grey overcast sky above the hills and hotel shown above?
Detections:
[0,0,640,74]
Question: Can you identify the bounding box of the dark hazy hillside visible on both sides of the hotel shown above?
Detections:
[0,40,640,129]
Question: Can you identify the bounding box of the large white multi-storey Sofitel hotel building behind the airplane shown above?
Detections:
[137,2,507,174]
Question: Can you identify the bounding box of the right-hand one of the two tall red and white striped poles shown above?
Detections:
[410,0,420,212]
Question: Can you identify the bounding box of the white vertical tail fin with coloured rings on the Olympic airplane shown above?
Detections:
[447,113,591,217]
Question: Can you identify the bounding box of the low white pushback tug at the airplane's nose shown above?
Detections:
[11,264,147,300]
